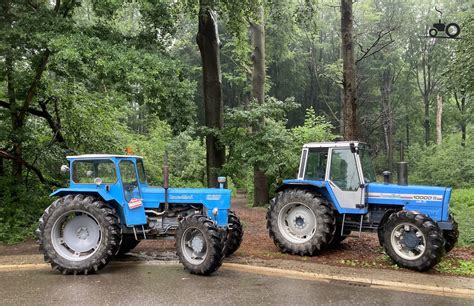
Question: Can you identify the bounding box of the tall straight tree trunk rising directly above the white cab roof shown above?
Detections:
[341,0,359,140]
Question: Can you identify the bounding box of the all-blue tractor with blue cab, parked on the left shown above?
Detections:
[37,154,243,275]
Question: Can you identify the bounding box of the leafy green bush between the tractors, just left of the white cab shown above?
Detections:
[218,98,335,203]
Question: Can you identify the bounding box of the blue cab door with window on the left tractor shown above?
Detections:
[119,159,146,226]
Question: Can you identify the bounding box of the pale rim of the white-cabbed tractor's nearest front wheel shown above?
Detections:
[391,223,426,260]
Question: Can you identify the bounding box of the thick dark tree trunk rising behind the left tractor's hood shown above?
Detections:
[196,0,225,187]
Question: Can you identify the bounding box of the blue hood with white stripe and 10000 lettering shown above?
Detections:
[367,183,452,221]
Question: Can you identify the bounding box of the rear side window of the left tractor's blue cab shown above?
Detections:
[72,160,117,184]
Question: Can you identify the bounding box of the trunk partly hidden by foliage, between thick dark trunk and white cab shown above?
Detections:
[250,6,269,206]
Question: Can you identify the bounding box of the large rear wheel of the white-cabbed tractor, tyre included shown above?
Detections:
[267,189,336,256]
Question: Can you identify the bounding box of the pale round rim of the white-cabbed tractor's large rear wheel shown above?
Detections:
[278,203,316,243]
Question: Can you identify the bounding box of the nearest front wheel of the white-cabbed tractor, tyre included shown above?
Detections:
[384,210,444,271]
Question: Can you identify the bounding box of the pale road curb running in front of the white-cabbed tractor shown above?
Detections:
[222,263,474,299]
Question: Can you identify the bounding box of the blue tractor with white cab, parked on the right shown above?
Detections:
[267,141,459,271]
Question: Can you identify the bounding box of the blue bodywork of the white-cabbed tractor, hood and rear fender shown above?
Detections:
[277,179,451,222]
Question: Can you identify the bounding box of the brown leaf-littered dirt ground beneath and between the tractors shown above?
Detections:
[0,194,474,277]
